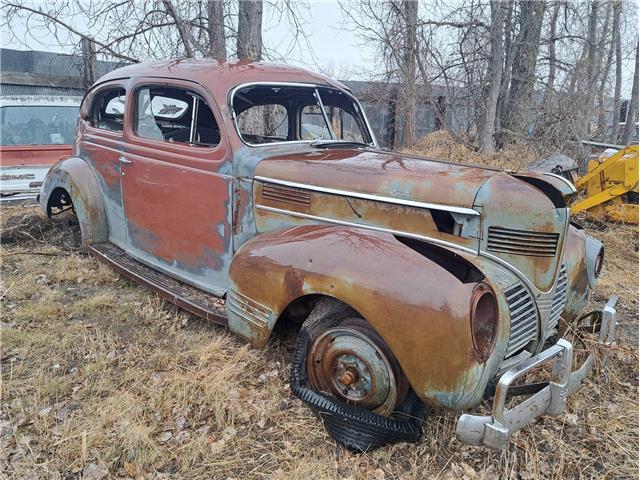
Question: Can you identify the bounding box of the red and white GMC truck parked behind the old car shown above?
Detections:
[0,95,82,201]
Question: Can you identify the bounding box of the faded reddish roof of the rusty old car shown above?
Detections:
[94,58,349,102]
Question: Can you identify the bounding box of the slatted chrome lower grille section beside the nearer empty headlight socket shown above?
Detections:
[505,283,538,358]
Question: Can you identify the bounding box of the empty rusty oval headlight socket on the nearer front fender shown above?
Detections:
[470,283,498,360]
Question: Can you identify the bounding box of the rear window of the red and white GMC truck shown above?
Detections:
[0,105,79,145]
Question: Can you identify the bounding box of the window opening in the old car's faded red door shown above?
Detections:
[134,86,220,147]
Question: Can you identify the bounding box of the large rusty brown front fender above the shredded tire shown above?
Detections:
[227,225,508,408]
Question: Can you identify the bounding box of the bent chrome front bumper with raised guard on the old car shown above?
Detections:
[456,295,618,449]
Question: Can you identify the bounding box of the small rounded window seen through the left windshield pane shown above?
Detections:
[238,104,289,143]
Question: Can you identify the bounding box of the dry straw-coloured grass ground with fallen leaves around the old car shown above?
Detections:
[0,138,638,480]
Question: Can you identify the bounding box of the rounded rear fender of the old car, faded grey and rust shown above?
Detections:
[40,157,109,246]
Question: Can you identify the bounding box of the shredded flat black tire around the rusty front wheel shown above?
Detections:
[291,299,427,451]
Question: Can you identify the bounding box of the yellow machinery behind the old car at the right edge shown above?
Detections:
[571,144,638,225]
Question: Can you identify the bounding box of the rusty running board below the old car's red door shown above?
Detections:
[88,242,228,325]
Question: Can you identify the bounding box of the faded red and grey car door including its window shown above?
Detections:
[120,78,232,295]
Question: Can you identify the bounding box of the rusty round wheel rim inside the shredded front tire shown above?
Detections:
[307,322,398,415]
